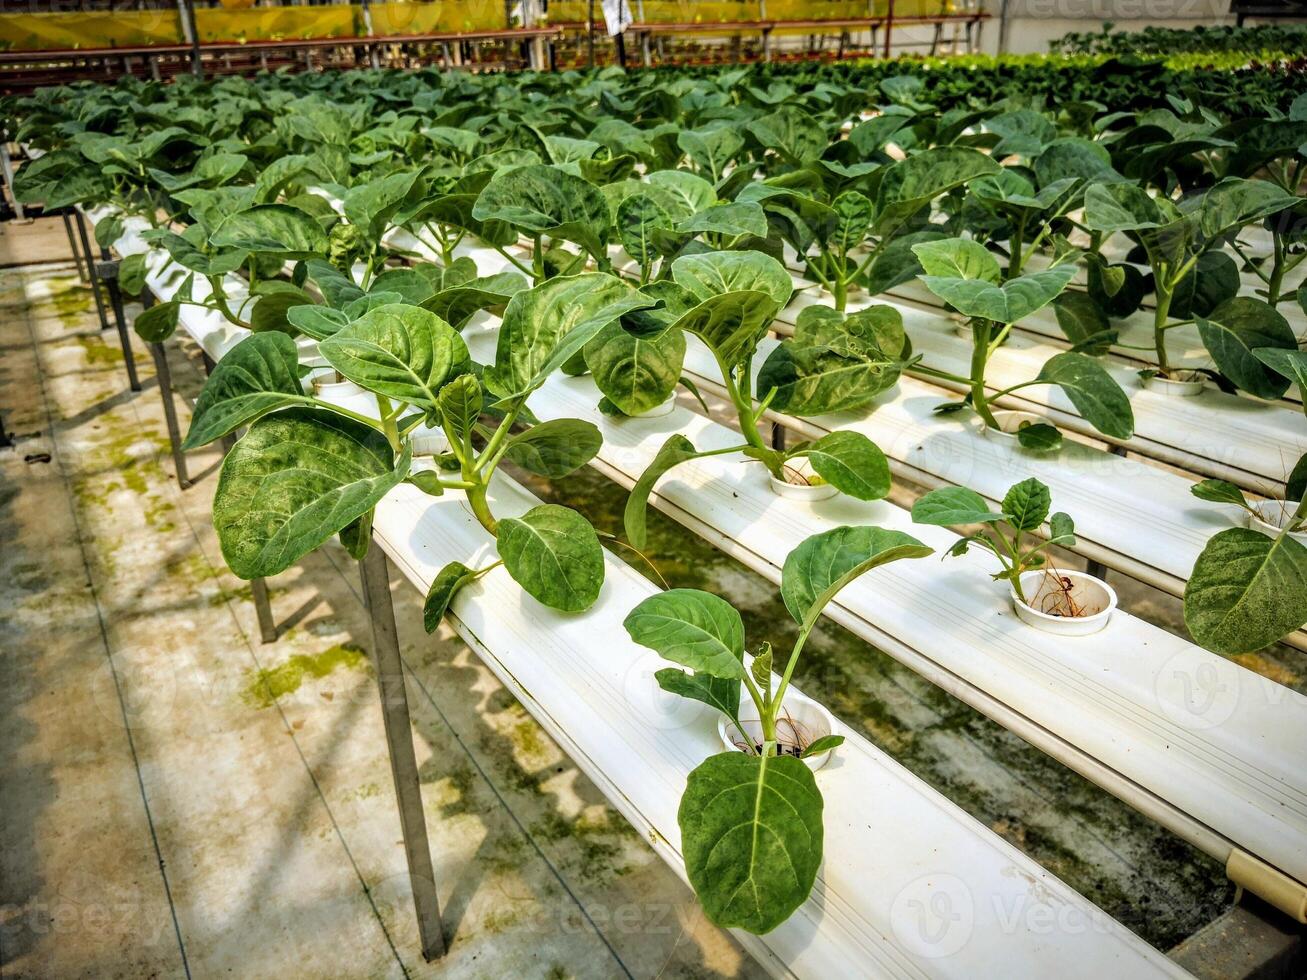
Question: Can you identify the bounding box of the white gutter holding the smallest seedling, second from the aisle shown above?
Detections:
[464,316,1307,915]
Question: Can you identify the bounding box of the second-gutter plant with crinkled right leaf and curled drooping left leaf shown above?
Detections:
[619,252,899,549]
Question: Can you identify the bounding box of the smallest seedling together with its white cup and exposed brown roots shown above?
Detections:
[912,477,1116,634]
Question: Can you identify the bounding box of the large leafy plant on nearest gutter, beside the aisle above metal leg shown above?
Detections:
[186,273,648,616]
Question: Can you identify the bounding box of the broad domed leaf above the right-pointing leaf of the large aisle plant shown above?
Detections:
[472,165,610,259]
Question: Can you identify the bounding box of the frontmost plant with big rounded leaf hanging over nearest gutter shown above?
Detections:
[625,527,931,934]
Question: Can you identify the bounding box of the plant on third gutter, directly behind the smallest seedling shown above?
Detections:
[911,238,1134,451]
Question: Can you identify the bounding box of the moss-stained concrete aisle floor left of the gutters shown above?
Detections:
[0,257,758,977]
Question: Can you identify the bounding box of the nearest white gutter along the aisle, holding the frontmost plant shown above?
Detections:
[96,211,1187,980]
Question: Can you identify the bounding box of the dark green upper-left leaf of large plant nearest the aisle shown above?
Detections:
[182,333,310,451]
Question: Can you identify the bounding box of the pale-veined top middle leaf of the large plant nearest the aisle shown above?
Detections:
[318,303,471,408]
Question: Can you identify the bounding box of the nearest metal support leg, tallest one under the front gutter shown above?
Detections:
[358,540,444,962]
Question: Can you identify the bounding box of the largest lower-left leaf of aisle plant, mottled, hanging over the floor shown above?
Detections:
[213,408,409,579]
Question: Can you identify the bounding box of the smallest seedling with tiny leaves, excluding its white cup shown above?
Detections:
[912,477,1076,615]
